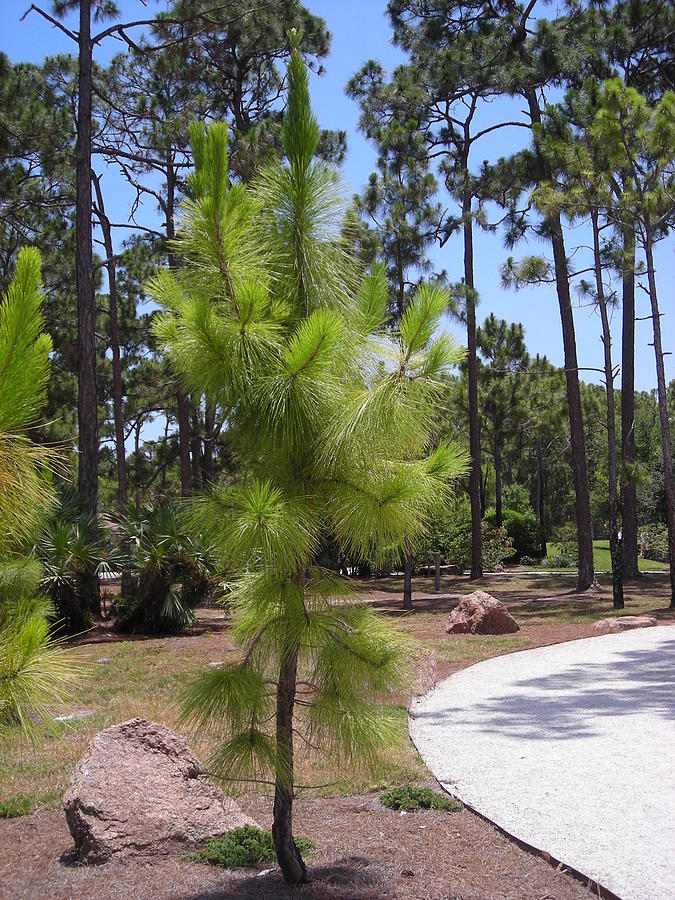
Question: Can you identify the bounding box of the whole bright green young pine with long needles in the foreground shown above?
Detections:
[151,39,466,882]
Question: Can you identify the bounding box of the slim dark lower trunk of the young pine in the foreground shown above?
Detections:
[272,636,309,884]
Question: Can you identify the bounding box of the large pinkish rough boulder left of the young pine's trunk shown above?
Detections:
[63,719,255,863]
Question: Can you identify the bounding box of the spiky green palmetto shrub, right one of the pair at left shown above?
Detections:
[117,504,213,632]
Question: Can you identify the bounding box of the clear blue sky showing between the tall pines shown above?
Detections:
[0,0,675,398]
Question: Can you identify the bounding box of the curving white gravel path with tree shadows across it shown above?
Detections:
[410,626,675,900]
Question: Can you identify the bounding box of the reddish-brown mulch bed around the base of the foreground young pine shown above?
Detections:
[0,794,590,900]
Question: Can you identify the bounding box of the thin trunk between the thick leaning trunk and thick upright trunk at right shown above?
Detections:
[591,211,623,609]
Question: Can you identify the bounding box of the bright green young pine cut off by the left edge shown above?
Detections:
[0,248,77,733]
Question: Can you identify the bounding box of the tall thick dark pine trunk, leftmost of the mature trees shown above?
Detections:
[75,0,98,516]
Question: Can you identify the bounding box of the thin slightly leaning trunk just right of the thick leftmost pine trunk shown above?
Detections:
[91,172,128,510]
